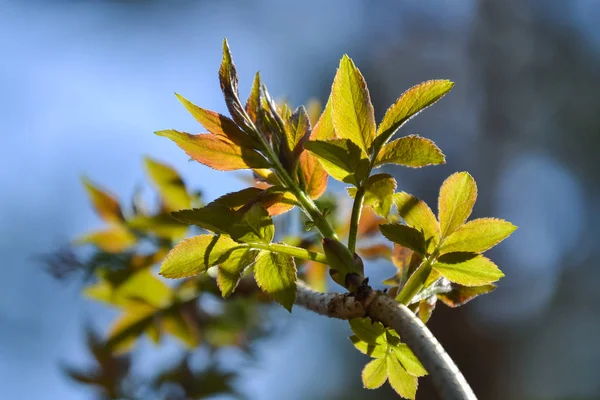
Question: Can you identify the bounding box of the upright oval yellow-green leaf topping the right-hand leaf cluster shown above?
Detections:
[438,172,477,238]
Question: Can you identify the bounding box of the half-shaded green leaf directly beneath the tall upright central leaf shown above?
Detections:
[304,139,369,186]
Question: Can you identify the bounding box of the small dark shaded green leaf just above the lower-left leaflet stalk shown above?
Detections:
[229,203,275,243]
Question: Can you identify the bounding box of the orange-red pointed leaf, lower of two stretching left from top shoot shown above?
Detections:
[155,129,270,171]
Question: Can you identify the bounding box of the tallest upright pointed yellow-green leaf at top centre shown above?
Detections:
[331,55,376,154]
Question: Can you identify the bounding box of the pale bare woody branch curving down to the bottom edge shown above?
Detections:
[296,282,477,400]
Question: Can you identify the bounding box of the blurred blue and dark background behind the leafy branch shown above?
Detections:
[0,0,600,400]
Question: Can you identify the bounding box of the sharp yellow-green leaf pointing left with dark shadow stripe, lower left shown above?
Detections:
[159,235,239,278]
